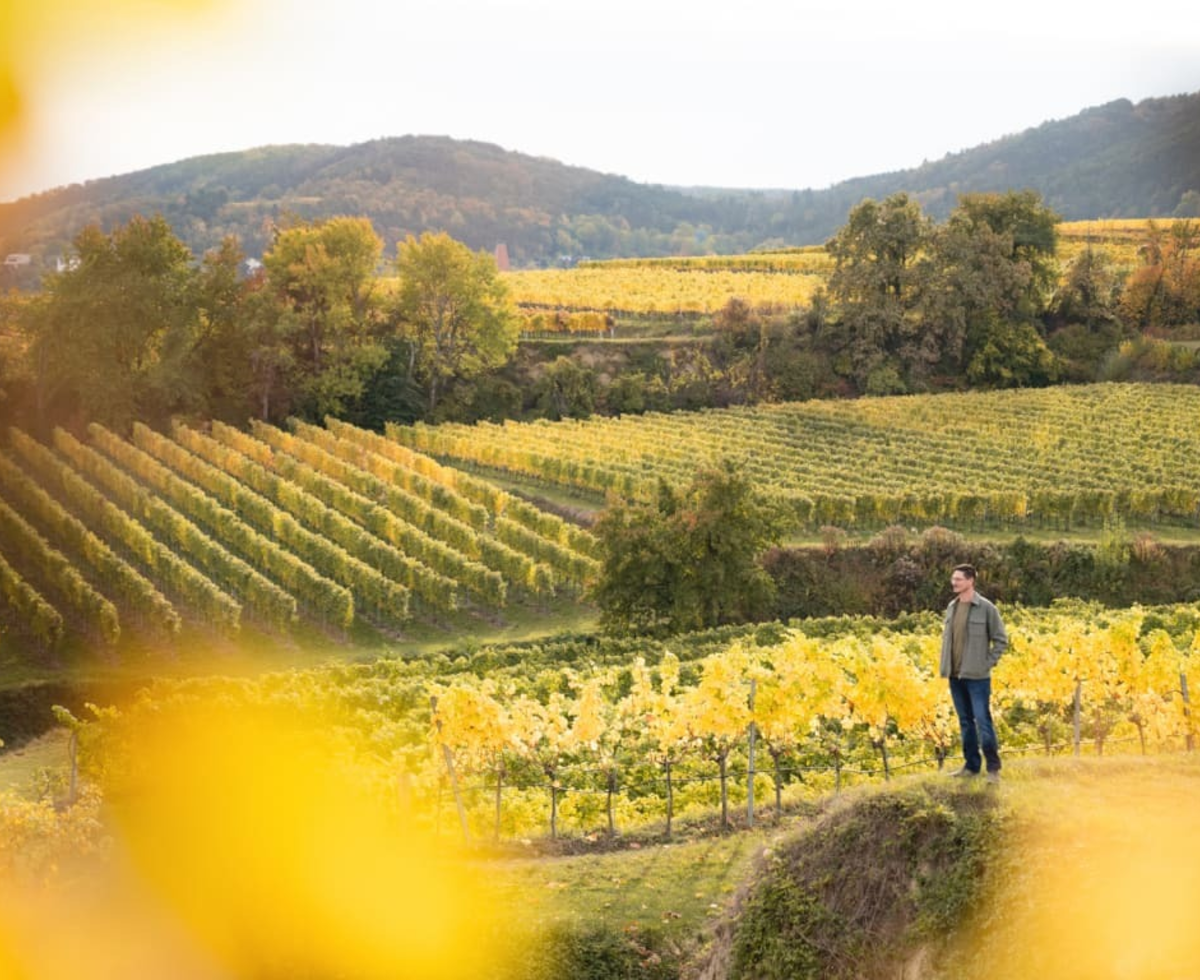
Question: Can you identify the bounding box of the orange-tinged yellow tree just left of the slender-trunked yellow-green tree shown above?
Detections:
[260,217,388,419]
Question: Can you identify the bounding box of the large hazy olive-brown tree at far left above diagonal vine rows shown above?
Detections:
[25,216,197,429]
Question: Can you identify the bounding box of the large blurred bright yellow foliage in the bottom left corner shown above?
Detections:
[0,705,504,980]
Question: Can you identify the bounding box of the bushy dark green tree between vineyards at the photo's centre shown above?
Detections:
[594,461,784,632]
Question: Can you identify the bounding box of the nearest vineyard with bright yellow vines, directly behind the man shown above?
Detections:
[25,601,1200,840]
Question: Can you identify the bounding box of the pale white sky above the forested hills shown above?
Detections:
[0,0,1200,200]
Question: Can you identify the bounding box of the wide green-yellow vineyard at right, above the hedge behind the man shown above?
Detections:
[388,384,1200,530]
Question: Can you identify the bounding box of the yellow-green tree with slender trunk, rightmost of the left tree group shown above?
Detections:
[395,232,520,416]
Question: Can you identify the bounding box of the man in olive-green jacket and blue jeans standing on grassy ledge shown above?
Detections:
[941,565,1008,782]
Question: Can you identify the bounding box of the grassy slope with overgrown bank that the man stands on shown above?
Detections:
[486,754,1200,980]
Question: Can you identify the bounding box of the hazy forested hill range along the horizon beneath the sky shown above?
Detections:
[0,94,1200,265]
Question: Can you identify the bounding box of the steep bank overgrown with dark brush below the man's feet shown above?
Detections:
[696,784,1002,980]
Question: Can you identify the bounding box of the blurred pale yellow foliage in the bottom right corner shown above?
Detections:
[959,771,1200,980]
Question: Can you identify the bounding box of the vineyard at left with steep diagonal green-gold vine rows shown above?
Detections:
[0,422,596,650]
